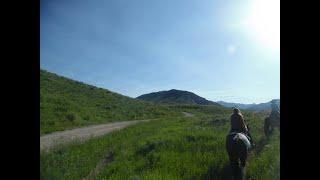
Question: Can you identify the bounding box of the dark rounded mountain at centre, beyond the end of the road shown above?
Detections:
[137,89,220,106]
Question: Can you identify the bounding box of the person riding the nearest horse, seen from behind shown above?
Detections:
[230,108,254,146]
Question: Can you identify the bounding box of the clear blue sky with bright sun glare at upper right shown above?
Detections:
[40,0,280,103]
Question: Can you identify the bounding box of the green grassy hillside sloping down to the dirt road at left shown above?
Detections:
[40,70,178,134]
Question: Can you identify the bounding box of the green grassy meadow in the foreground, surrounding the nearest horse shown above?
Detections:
[40,106,280,180]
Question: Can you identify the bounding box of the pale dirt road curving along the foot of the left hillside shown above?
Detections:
[40,120,150,150]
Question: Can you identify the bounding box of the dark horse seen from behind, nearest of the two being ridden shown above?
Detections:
[226,128,252,180]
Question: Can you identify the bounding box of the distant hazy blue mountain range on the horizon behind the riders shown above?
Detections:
[217,99,280,111]
